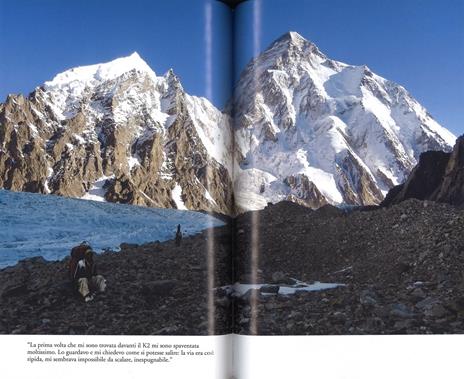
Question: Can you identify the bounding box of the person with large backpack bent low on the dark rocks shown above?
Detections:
[69,242,106,302]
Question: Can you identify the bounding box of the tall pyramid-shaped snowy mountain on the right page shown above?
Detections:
[234,32,456,210]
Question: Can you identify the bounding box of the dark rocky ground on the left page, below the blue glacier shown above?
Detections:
[0,227,232,335]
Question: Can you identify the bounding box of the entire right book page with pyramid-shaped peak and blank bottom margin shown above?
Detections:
[234,0,464,378]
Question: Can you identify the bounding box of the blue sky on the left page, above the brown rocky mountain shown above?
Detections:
[0,0,232,106]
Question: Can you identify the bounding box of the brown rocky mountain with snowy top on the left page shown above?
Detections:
[0,53,233,213]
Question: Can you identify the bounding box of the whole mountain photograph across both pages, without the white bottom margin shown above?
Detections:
[0,0,464,378]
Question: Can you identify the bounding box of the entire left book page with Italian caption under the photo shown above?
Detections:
[0,0,234,378]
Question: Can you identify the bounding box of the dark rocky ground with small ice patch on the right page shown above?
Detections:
[235,200,464,335]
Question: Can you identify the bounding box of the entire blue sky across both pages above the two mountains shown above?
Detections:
[0,0,464,134]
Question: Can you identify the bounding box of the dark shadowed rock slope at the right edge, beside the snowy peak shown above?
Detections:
[381,136,464,206]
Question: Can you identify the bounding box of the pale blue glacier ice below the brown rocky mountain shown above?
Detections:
[0,190,224,267]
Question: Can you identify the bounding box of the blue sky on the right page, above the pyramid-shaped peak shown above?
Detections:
[235,0,464,134]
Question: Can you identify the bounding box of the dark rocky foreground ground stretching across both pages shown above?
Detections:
[0,200,464,335]
